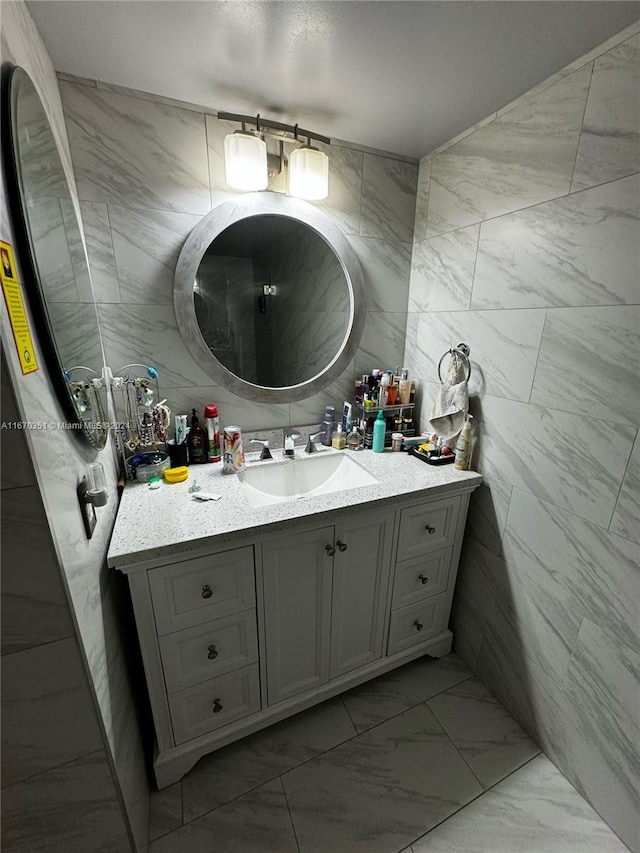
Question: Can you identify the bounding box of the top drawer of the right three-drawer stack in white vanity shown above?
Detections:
[396,497,460,562]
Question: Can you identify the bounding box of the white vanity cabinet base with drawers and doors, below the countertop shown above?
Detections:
[114,475,480,788]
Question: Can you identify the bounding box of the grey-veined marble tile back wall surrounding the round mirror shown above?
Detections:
[60,75,418,430]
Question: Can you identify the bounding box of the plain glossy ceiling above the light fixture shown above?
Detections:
[27,0,640,158]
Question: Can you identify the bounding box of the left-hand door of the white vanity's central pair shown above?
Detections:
[262,527,333,705]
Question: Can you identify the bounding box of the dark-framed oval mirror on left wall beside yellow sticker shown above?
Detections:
[3,68,107,449]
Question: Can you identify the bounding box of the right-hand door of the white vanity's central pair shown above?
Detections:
[330,512,393,678]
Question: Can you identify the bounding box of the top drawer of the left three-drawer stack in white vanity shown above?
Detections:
[149,546,256,635]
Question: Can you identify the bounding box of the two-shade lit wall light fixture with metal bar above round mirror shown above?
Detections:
[218,113,331,201]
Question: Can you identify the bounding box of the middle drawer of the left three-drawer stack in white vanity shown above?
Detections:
[160,610,258,693]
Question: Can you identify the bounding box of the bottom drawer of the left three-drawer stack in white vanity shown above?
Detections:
[169,664,260,745]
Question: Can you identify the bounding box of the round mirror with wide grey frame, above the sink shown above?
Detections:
[174,193,366,402]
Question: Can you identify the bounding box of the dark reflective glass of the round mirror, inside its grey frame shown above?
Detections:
[194,215,350,388]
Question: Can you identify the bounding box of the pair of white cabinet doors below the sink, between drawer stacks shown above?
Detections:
[262,511,394,705]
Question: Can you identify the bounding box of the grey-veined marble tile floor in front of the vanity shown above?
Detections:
[149,654,627,853]
